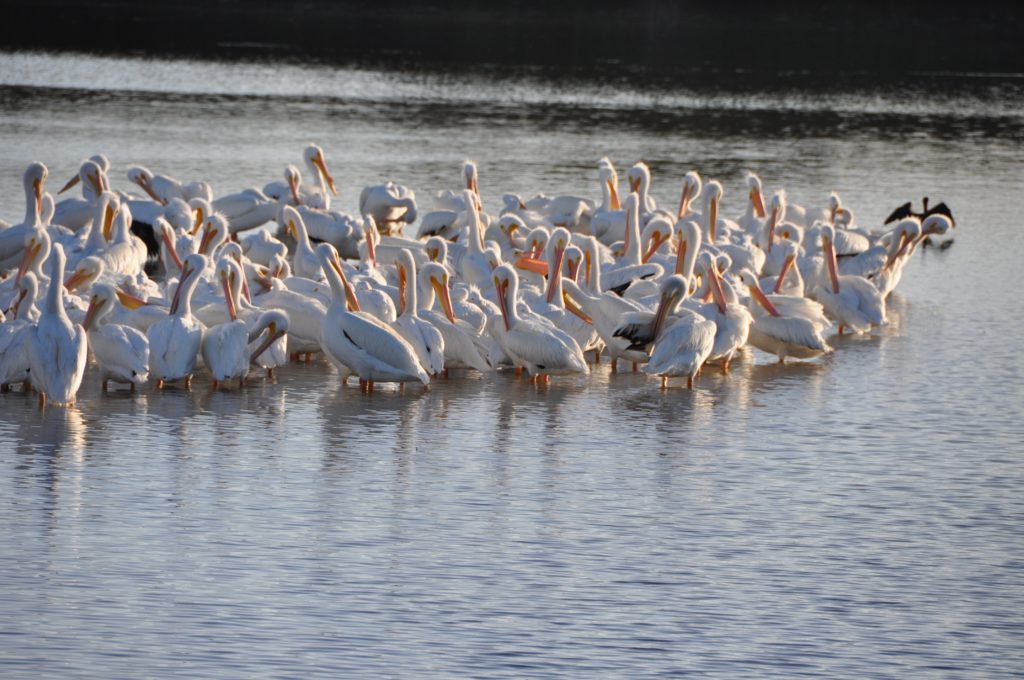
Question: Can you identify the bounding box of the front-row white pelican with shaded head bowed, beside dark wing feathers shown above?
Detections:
[643,274,717,389]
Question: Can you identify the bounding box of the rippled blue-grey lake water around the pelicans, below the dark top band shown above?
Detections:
[0,50,1024,678]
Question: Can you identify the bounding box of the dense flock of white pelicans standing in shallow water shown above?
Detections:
[0,144,954,405]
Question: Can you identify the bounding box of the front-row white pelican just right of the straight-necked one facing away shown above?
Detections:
[83,284,150,392]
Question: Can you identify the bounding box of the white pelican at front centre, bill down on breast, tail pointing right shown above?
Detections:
[493,264,590,379]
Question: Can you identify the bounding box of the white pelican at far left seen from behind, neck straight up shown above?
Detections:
[29,246,88,406]
